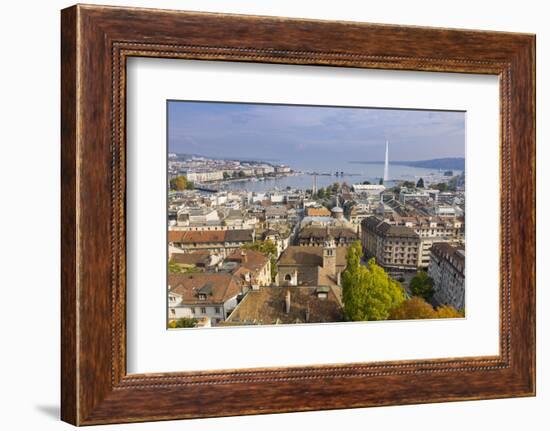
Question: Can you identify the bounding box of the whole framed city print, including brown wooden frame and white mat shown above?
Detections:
[61,5,535,425]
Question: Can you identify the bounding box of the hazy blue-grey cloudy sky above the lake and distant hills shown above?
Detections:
[168,101,465,169]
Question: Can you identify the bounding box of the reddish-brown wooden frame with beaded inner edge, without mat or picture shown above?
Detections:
[61,5,535,425]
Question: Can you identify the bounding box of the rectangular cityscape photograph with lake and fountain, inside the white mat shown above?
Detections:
[165,100,466,329]
